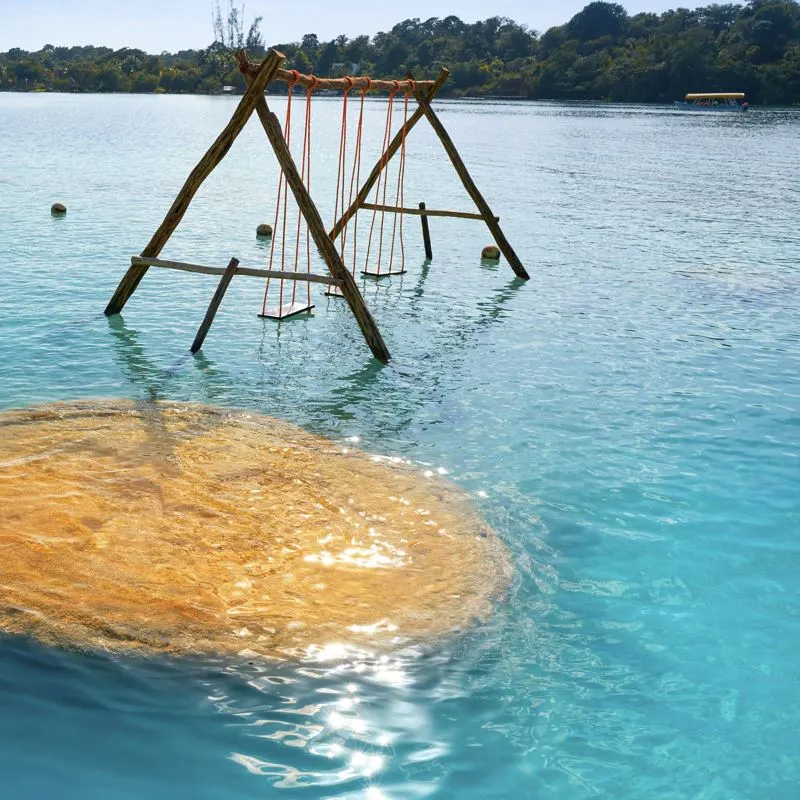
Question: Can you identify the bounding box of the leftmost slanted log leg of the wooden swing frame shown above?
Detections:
[105,50,286,316]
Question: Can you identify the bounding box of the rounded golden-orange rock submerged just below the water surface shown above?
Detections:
[0,401,509,657]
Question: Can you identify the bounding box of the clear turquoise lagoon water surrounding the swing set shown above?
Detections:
[0,94,800,800]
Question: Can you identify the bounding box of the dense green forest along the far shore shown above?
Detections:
[0,0,800,105]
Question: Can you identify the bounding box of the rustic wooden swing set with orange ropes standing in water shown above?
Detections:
[105,50,529,363]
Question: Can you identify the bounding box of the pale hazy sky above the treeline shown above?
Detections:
[0,0,684,53]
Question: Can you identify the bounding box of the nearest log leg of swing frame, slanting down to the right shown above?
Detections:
[236,53,390,363]
